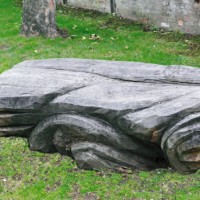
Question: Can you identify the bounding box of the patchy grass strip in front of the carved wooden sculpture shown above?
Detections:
[0,138,200,200]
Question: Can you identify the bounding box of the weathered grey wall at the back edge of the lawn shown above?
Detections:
[57,0,200,34]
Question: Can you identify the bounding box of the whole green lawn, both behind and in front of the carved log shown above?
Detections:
[0,0,200,200]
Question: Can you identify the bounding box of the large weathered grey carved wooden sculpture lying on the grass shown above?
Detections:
[0,59,200,172]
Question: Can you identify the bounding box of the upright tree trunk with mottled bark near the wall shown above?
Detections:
[21,0,58,37]
